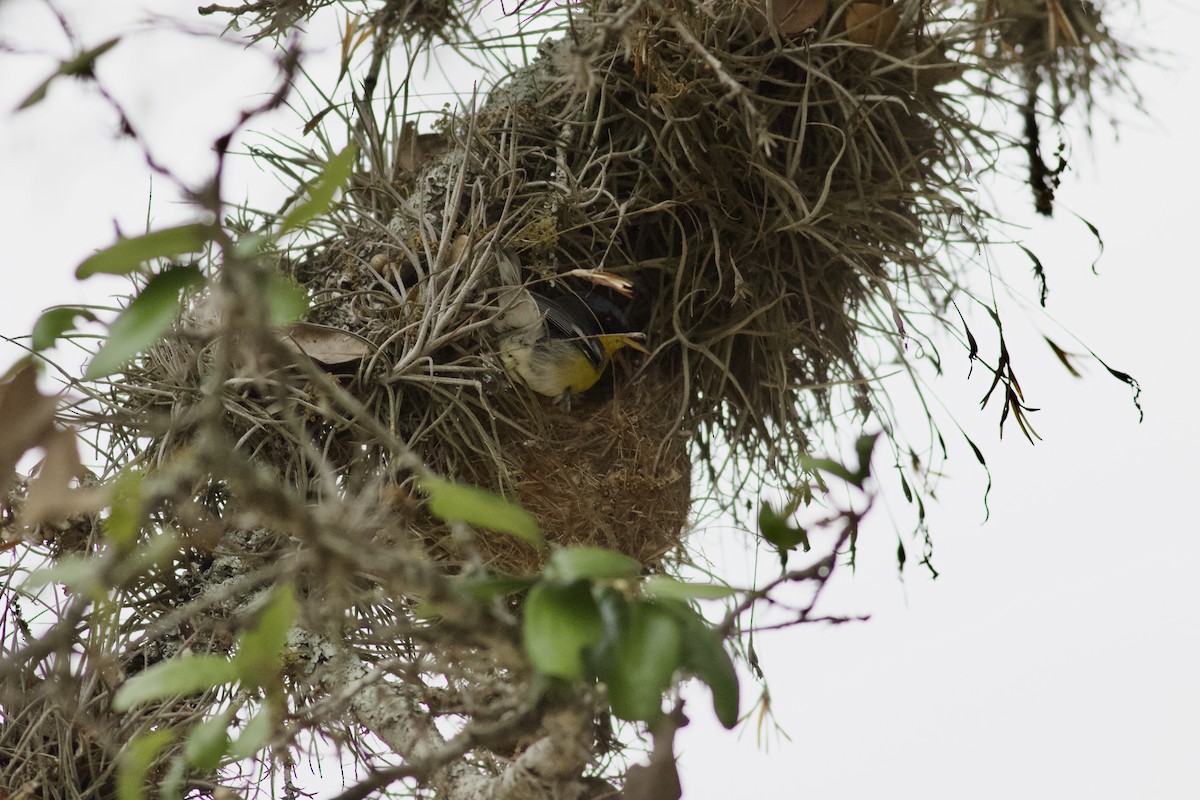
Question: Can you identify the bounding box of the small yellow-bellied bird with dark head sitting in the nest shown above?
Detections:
[500,289,649,411]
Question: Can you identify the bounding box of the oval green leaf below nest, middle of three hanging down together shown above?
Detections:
[600,600,683,722]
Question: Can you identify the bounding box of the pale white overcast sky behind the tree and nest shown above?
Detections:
[0,0,1200,800]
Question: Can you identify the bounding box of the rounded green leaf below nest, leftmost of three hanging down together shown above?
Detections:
[522,581,604,679]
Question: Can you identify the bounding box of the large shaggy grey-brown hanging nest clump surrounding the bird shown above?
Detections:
[84,0,1120,571]
